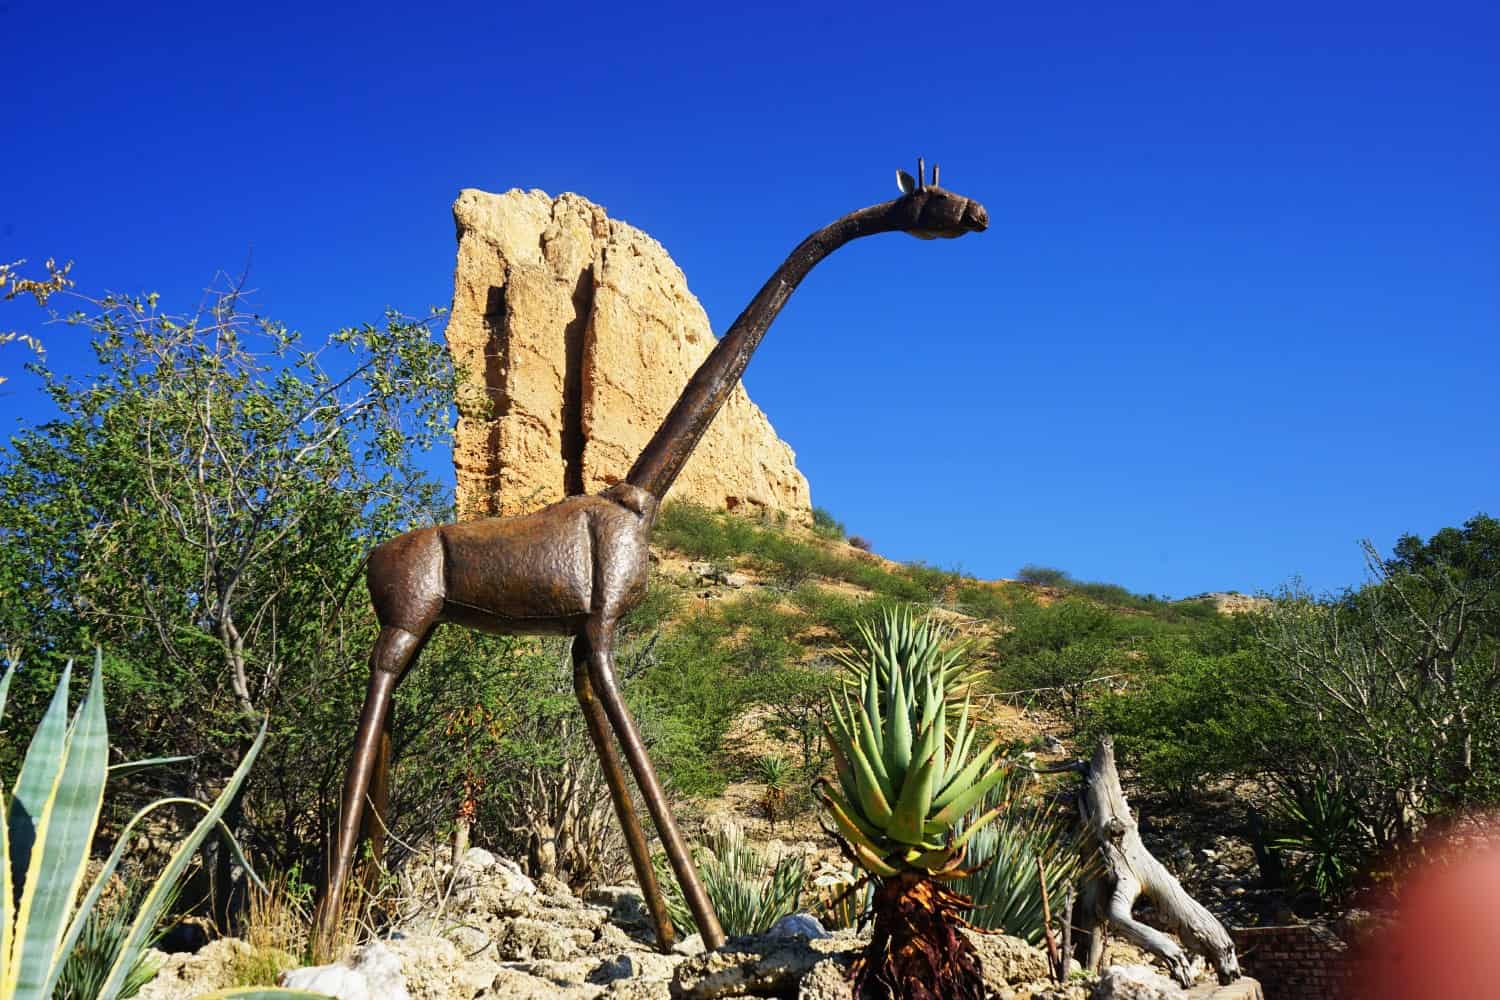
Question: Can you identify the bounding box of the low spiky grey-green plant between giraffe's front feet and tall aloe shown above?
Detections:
[656,826,806,937]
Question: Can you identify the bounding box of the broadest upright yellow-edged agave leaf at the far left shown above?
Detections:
[8,658,110,999]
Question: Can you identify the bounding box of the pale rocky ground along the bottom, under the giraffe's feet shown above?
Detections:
[140,849,1259,1000]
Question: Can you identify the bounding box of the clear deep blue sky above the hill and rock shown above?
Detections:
[0,0,1500,595]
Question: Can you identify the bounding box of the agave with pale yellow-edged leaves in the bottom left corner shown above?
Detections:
[0,654,266,1000]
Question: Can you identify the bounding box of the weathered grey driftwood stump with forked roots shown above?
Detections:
[1079,736,1239,987]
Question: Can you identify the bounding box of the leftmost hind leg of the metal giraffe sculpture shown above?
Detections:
[314,625,426,958]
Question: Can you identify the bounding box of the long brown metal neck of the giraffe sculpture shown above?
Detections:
[626,198,905,499]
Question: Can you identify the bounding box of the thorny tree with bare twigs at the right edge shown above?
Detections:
[1259,514,1500,852]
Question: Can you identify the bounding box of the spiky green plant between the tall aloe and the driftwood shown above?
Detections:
[953,769,1088,945]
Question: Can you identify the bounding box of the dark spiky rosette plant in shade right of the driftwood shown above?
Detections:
[1272,775,1373,903]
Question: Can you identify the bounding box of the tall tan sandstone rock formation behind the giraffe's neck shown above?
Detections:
[447,189,810,517]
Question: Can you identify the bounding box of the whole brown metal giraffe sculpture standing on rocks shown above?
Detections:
[317,160,989,951]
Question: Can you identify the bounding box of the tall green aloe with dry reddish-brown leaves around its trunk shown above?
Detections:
[818,613,1007,1000]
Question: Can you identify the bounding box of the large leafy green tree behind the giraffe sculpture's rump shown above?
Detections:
[0,274,455,870]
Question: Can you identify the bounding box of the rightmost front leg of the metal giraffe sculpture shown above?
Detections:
[585,618,725,951]
